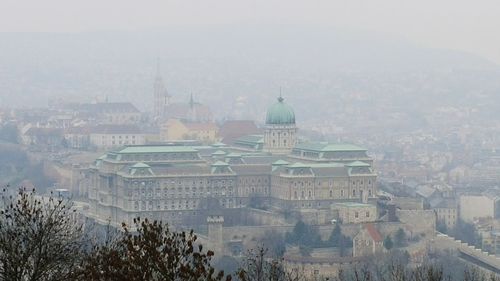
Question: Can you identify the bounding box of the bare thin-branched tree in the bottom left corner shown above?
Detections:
[0,189,83,281]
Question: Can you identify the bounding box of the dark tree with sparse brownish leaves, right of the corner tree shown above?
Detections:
[81,219,231,281]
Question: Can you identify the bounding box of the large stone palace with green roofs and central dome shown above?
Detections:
[81,97,377,226]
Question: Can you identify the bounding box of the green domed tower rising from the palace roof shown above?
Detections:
[264,95,297,154]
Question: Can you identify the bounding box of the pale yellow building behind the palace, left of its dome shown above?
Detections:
[160,119,218,143]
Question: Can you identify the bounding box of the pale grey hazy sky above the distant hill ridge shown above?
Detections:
[0,0,500,63]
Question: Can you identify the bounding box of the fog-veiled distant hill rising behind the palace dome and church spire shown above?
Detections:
[0,25,500,122]
